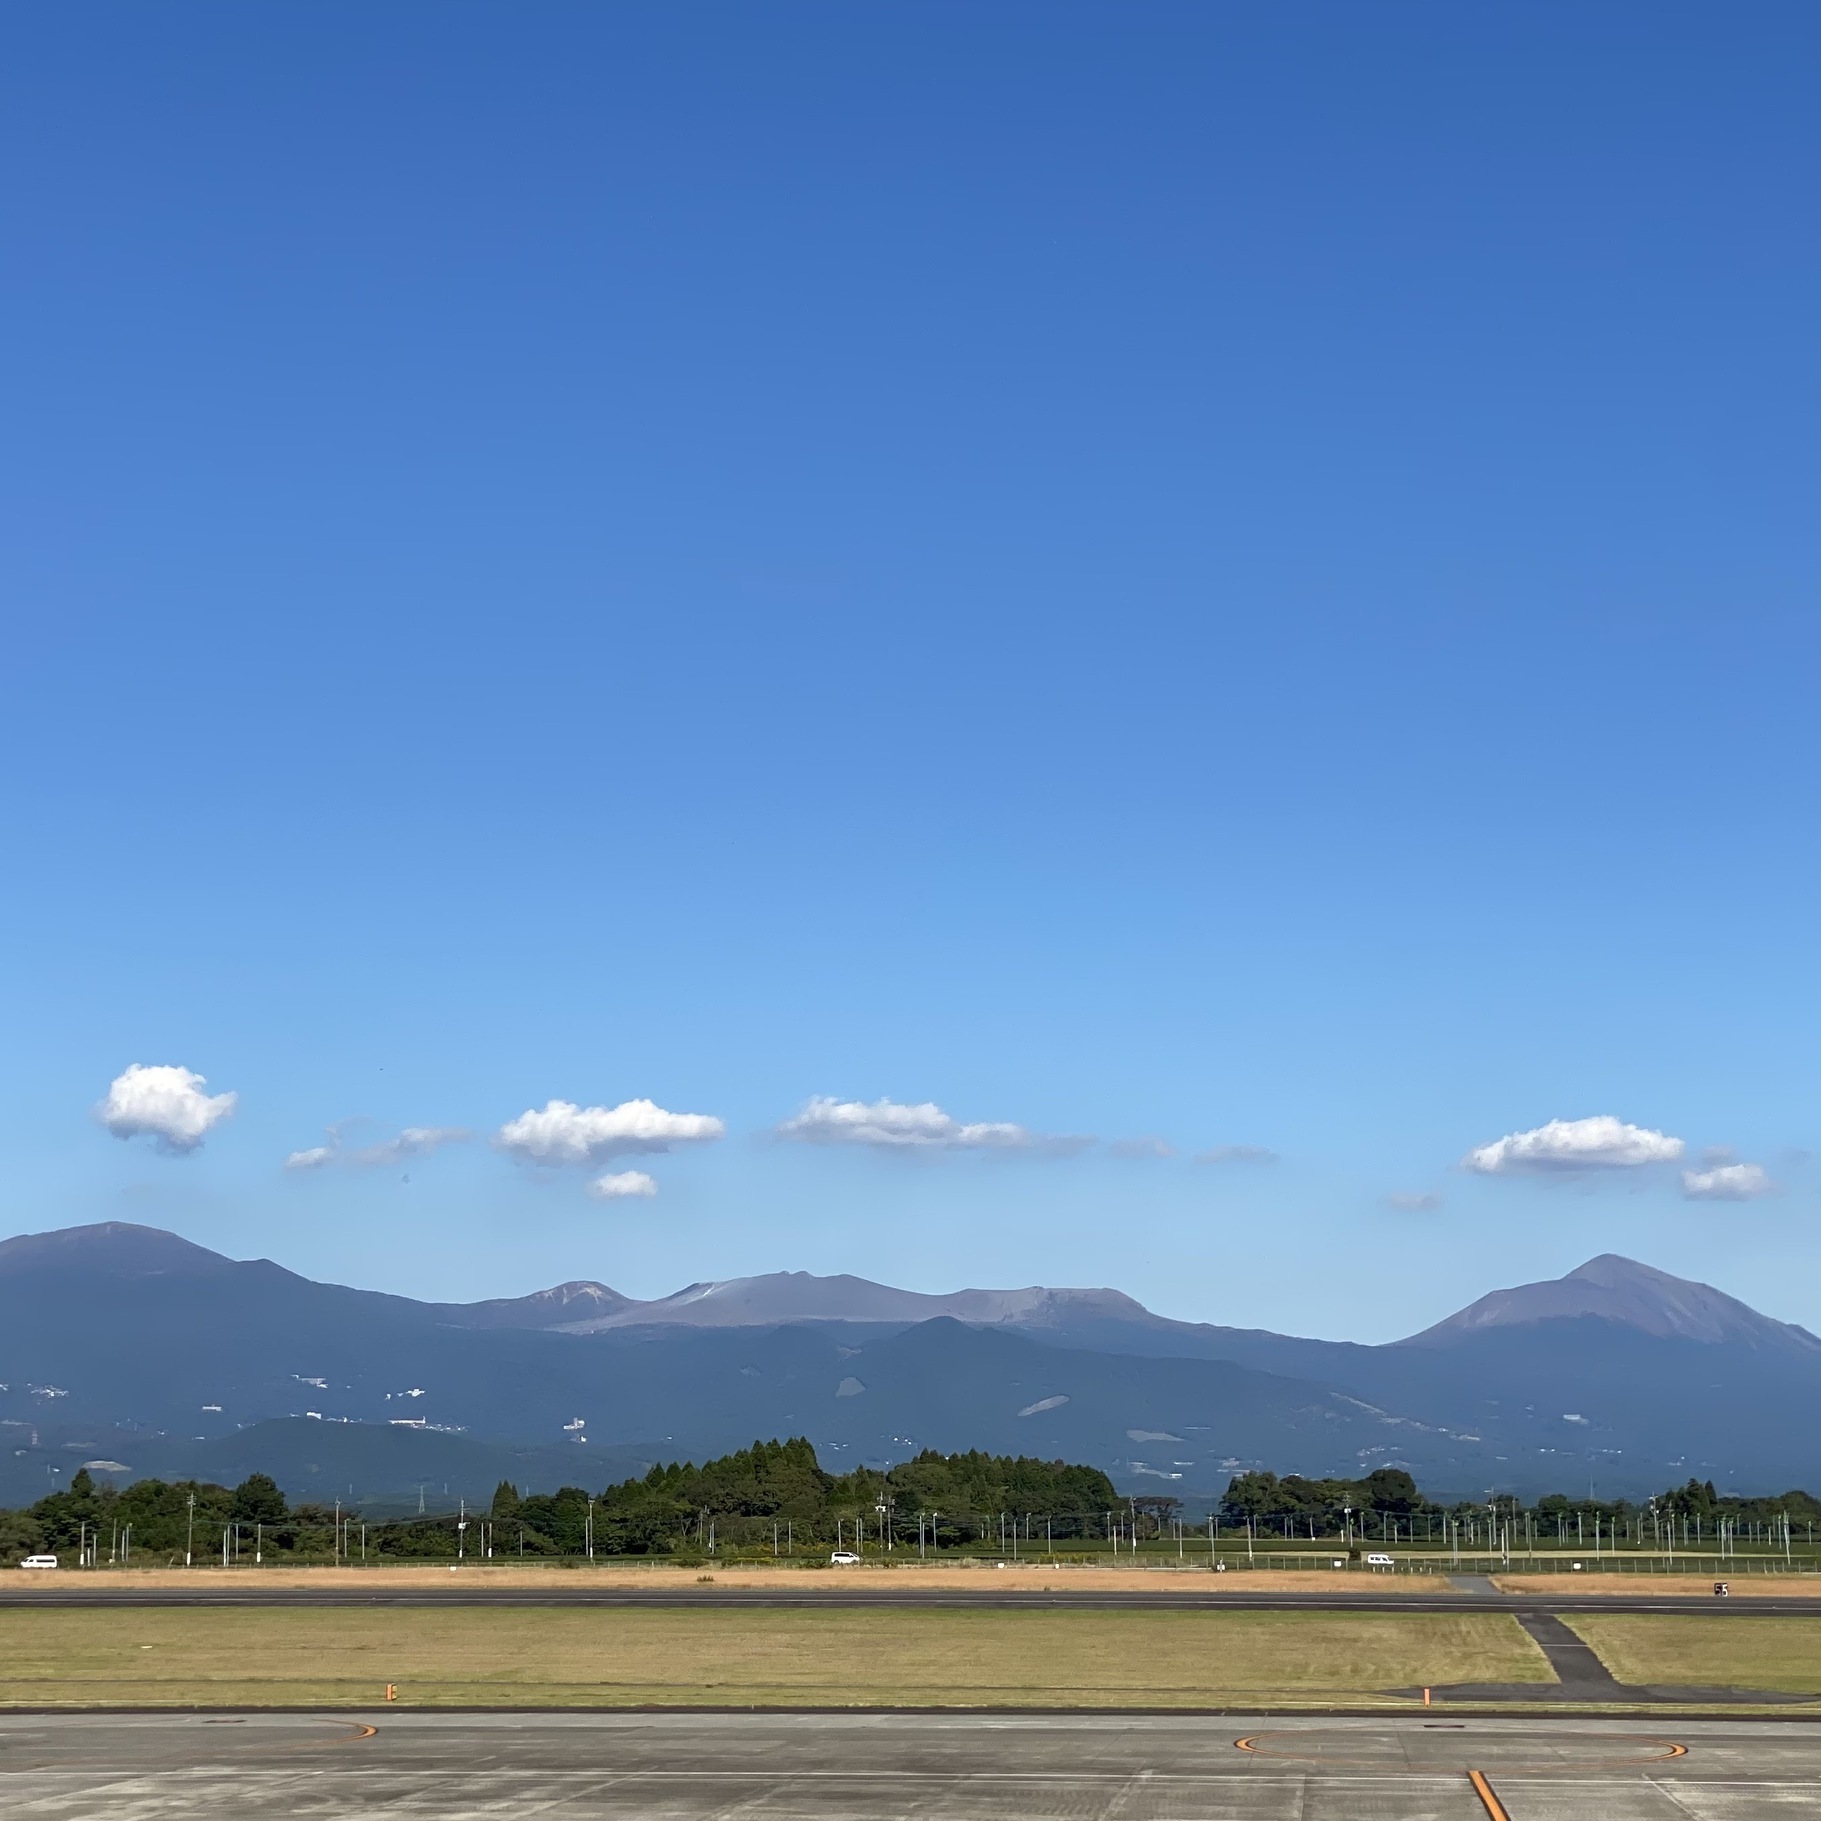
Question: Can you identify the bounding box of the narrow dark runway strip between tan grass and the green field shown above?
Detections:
[0,1572,1821,1619]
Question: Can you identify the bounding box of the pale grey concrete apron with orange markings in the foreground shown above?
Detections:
[0,1710,1821,1821]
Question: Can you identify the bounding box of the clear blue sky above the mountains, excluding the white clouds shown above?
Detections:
[0,0,1821,1338]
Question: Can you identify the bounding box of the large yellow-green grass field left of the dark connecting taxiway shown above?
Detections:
[0,1608,1551,1708]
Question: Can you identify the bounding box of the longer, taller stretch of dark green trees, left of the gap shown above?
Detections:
[0,1437,1125,1566]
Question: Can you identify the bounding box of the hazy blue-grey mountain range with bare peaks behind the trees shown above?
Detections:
[0,1222,1821,1504]
